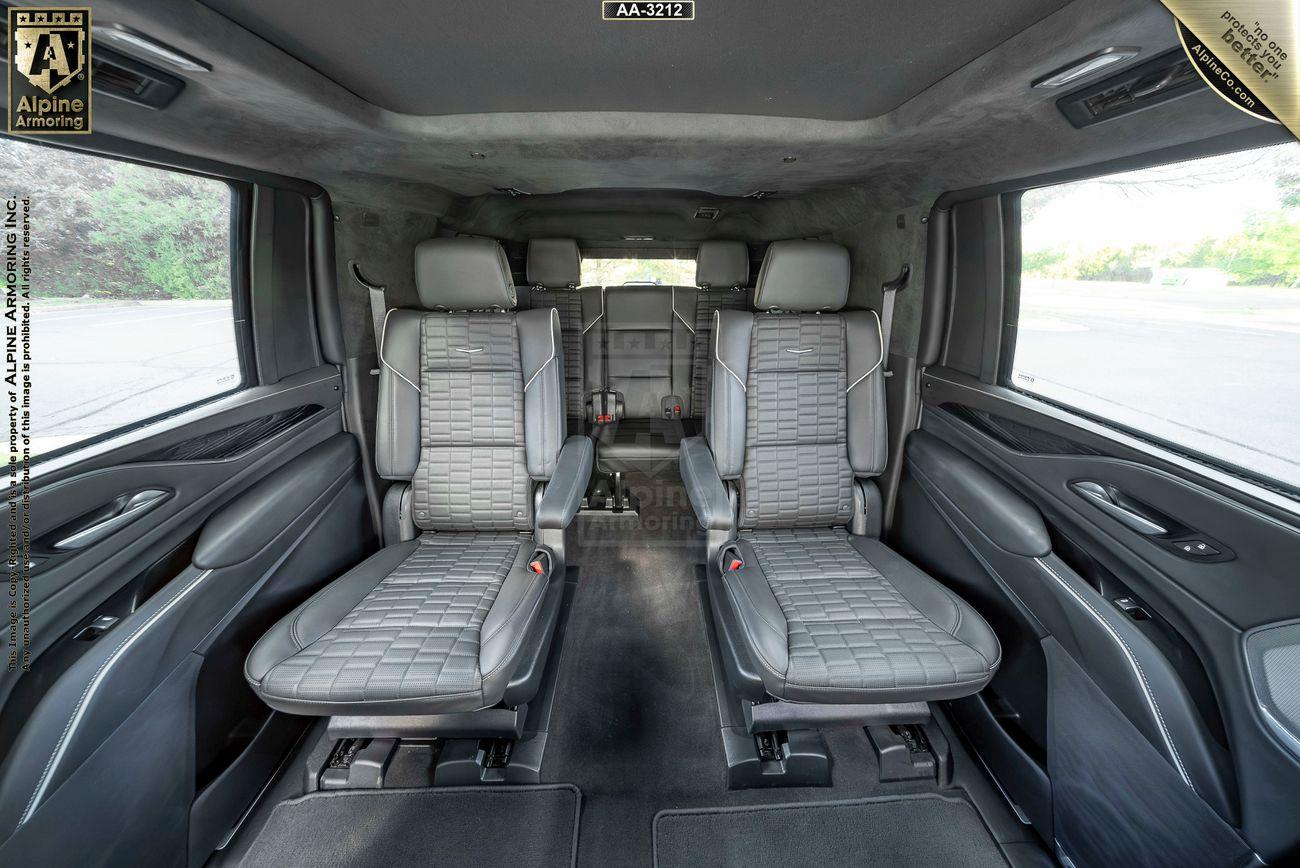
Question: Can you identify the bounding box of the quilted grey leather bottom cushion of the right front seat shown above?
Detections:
[723,529,1001,704]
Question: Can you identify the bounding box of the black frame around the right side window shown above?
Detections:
[996,147,1300,502]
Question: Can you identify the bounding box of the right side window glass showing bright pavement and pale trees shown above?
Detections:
[1009,144,1300,490]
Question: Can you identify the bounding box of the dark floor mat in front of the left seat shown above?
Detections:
[239,784,582,868]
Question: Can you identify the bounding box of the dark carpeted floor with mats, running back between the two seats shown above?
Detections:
[229,475,1014,868]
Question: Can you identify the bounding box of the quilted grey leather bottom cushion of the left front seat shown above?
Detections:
[244,533,547,716]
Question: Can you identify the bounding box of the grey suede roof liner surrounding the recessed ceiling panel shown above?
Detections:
[65,0,1284,217]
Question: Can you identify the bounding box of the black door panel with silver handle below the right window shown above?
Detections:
[896,369,1300,865]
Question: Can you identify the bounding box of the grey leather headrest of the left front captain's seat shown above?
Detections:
[415,238,515,311]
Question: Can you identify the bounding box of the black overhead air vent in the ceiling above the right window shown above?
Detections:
[1057,48,1206,129]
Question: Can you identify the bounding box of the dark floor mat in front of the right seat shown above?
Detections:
[654,795,1006,868]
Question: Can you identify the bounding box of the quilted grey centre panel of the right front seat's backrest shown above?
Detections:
[740,313,854,528]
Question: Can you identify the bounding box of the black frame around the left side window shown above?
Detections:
[4,135,257,468]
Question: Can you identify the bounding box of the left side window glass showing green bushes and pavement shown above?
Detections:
[0,139,244,461]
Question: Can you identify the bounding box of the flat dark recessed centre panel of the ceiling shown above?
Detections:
[204,0,1066,121]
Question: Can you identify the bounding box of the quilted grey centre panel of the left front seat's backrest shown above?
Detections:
[411,312,533,530]
